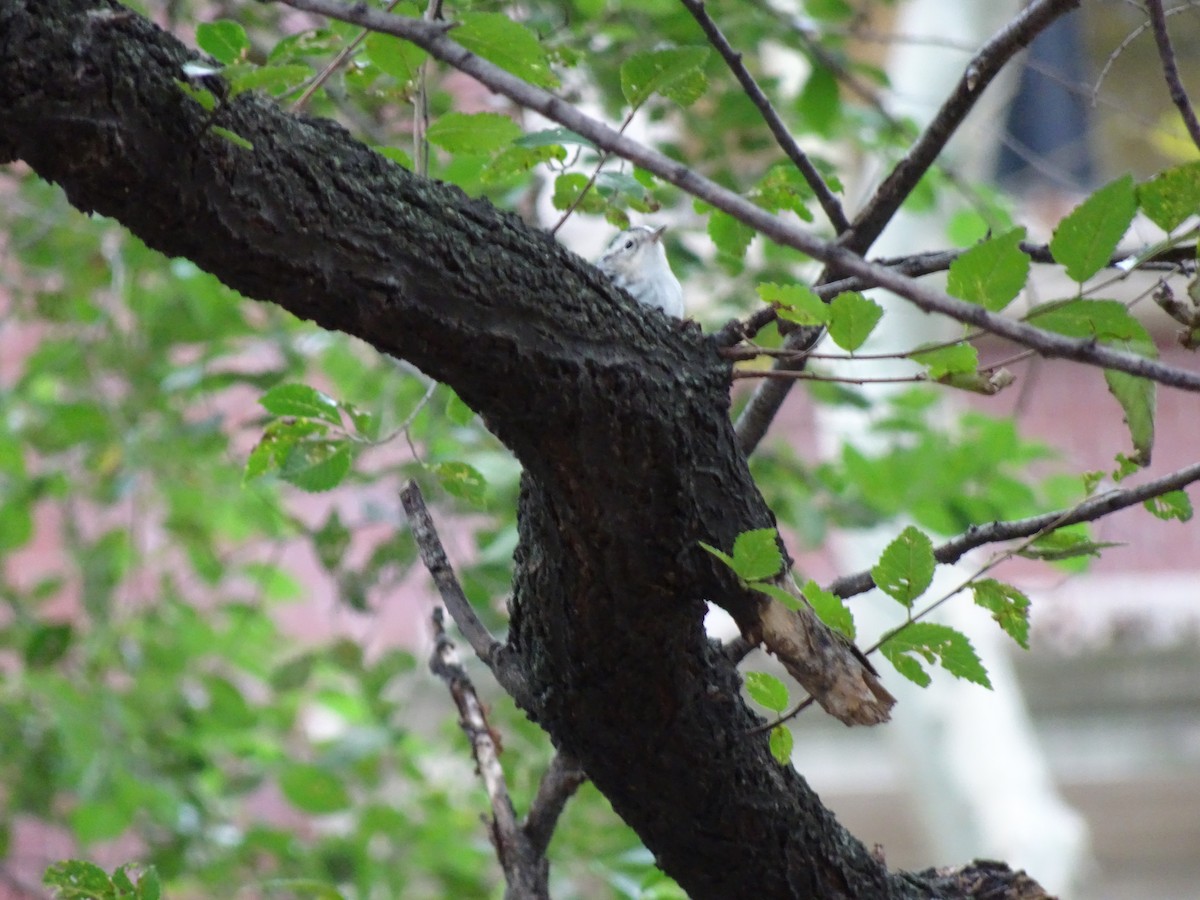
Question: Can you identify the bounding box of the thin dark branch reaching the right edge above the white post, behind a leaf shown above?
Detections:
[828,463,1200,598]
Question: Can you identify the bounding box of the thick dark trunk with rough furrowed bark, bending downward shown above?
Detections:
[0,0,1051,898]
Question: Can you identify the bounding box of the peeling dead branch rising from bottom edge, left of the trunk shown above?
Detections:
[429,614,550,900]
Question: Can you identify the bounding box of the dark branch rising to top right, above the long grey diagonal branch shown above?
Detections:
[841,0,1080,253]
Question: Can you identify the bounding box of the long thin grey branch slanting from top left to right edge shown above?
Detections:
[282,0,1200,400]
